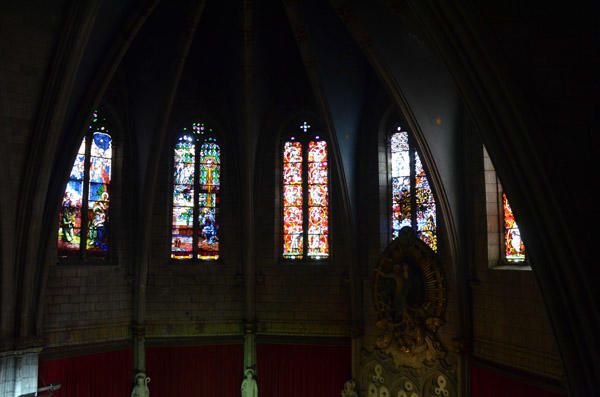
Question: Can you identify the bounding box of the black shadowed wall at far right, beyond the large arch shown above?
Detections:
[429,2,600,395]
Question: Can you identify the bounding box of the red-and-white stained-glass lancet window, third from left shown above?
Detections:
[282,121,329,260]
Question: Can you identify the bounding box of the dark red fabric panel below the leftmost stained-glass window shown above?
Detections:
[38,349,133,397]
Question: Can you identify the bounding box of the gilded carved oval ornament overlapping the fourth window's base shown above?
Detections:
[373,228,446,368]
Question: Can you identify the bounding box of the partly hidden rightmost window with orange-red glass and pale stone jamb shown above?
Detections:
[483,147,530,270]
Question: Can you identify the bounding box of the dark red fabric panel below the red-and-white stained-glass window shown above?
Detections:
[256,344,352,397]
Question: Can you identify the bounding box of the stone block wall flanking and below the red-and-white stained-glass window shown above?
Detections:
[255,131,350,336]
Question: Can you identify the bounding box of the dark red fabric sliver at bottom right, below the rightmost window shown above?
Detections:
[471,366,566,397]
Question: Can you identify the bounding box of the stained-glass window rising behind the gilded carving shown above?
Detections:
[389,126,437,251]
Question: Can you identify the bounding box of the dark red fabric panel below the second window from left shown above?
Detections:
[146,345,244,397]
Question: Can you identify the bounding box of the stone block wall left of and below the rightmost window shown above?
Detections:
[472,146,563,379]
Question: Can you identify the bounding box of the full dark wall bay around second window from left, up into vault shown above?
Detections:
[141,2,243,337]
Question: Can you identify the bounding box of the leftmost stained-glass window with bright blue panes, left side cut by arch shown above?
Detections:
[58,110,113,258]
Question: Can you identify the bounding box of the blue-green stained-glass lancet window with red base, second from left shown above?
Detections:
[171,122,221,260]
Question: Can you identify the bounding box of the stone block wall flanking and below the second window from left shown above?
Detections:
[146,128,244,337]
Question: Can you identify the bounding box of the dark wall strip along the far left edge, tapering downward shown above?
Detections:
[0,2,65,338]
